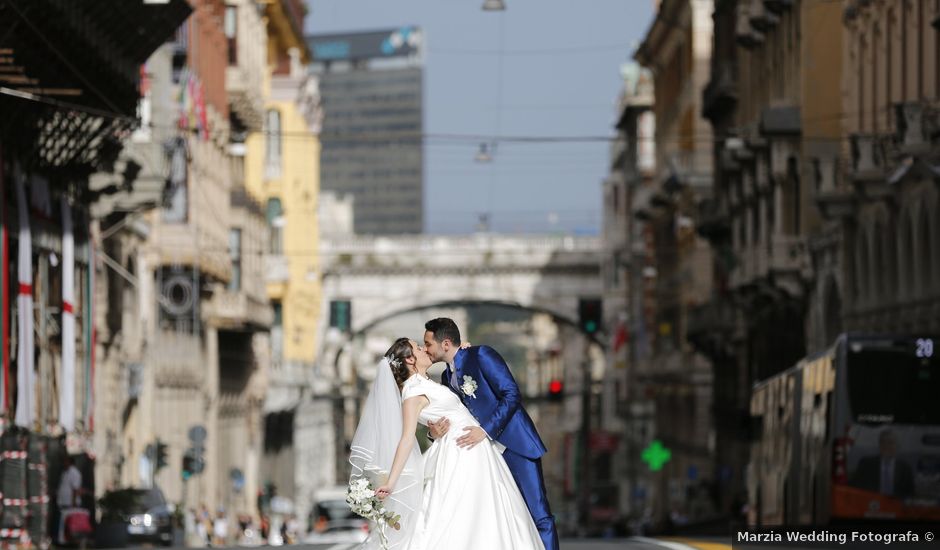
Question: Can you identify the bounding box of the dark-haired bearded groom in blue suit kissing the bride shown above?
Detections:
[424,317,558,550]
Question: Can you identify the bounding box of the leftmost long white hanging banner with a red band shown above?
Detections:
[14,174,36,428]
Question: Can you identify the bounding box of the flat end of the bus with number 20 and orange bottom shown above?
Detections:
[831,336,940,521]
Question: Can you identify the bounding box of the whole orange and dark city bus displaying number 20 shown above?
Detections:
[746,334,940,527]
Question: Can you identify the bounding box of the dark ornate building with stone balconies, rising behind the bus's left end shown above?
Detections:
[688,0,846,514]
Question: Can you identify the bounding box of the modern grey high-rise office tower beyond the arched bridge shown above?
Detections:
[307,27,424,235]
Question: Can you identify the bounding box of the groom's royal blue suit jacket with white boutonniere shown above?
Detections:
[441,346,546,460]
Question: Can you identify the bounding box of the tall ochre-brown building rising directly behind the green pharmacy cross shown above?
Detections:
[632,0,715,522]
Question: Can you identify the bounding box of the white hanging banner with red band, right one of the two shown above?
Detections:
[59,197,75,432]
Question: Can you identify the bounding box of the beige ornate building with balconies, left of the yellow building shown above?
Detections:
[94,0,273,532]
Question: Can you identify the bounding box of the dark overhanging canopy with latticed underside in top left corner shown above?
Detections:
[0,0,192,178]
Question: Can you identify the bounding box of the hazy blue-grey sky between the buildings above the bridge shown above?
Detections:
[306,0,653,235]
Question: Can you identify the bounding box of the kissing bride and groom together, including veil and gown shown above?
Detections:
[349,318,558,550]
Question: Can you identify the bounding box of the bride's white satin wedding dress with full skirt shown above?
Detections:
[393,374,544,550]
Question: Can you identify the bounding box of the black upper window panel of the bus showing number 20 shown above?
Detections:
[846,338,940,425]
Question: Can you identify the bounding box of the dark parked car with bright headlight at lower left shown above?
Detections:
[99,488,173,546]
